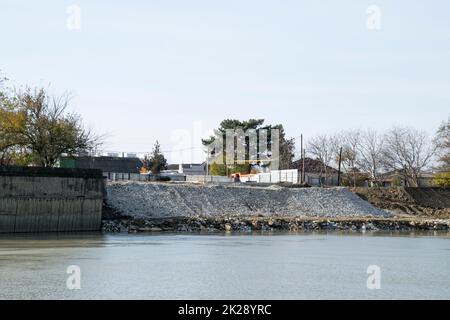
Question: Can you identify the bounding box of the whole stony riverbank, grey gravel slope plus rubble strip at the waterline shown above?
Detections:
[102,182,450,233]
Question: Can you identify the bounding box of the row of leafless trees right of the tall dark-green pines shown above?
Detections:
[306,119,450,186]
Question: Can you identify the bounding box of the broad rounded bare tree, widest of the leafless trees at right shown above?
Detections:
[383,127,436,187]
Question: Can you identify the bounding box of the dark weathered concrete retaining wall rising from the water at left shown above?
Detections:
[0,167,105,233]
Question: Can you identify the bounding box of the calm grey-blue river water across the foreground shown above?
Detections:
[0,232,450,299]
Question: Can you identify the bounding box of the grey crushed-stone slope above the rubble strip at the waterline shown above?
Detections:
[107,182,390,218]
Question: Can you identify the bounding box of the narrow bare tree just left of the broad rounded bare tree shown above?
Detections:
[358,129,384,185]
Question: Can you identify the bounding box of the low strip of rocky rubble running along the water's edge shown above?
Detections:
[102,215,450,233]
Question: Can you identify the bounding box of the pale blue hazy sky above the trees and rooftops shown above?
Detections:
[0,0,450,163]
